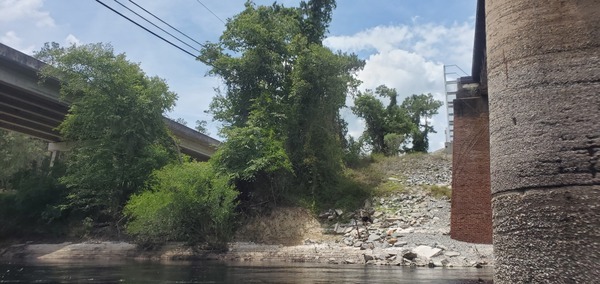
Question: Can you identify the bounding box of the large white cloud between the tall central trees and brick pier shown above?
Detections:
[325,20,473,150]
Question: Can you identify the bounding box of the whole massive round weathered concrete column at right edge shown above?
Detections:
[486,0,600,284]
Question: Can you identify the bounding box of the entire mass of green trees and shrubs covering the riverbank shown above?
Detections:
[0,0,441,250]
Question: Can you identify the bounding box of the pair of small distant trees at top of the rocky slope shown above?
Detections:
[352,85,442,156]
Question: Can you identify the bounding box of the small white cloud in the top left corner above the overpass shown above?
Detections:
[0,0,54,27]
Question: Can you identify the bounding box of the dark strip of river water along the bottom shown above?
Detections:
[0,261,493,284]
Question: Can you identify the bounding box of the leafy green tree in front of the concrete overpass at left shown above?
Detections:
[36,43,176,220]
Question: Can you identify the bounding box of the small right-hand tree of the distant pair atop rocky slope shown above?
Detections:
[401,94,444,152]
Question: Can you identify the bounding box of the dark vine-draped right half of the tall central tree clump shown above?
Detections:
[287,44,363,195]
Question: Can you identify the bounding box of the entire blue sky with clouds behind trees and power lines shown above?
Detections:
[0,0,476,150]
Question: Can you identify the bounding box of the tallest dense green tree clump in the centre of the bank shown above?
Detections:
[199,0,364,209]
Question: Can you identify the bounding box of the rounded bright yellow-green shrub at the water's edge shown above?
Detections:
[124,162,238,248]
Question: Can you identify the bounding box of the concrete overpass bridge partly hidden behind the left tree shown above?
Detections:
[0,44,220,160]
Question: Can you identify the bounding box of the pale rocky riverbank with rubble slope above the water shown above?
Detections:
[0,154,493,267]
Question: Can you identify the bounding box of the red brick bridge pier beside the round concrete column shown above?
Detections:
[450,96,492,244]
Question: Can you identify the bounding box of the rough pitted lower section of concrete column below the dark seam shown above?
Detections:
[493,185,600,283]
